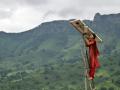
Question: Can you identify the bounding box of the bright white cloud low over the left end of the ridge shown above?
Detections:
[0,7,43,32]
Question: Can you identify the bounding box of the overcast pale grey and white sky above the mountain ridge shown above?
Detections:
[0,0,120,32]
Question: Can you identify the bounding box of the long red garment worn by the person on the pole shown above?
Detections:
[87,39,100,78]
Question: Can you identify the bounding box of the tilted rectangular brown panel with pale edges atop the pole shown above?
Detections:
[70,20,102,42]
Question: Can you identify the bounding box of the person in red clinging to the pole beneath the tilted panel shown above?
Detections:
[85,33,100,80]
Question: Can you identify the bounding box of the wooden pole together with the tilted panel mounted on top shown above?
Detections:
[70,20,102,90]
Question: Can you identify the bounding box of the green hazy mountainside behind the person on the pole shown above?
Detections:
[0,13,120,90]
